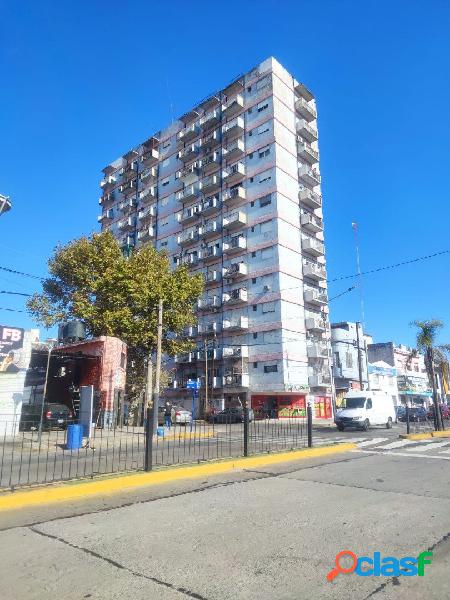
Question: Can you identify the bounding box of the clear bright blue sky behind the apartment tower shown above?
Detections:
[0,0,450,343]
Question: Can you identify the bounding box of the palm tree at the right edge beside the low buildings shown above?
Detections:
[411,319,450,430]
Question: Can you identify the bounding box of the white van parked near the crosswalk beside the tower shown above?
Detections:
[335,390,395,431]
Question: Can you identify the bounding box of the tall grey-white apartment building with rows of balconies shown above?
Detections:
[99,58,331,417]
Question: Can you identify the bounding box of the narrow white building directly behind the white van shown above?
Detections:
[331,321,368,399]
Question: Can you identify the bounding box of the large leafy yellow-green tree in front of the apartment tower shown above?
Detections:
[27,232,203,412]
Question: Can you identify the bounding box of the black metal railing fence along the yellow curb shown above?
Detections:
[0,415,311,489]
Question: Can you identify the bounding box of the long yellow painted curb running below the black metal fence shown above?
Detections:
[0,443,356,511]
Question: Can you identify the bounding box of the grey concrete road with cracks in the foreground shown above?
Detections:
[0,430,450,600]
